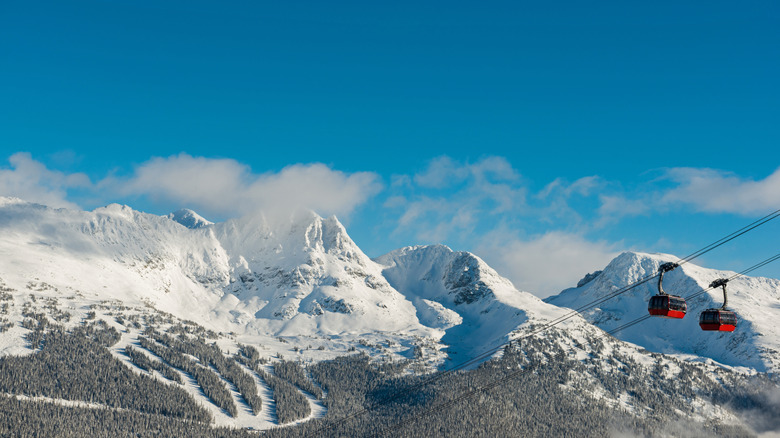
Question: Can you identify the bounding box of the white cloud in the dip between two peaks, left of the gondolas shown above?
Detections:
[475,230,619,298]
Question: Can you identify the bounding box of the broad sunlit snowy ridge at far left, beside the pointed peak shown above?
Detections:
[0,198,227,322]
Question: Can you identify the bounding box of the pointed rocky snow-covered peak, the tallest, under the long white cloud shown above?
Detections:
[211,212,422,335]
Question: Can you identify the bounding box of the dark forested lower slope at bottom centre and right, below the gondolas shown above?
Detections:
[267,334,760,438]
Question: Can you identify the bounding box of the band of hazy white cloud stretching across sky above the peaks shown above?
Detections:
[0,153,780,295]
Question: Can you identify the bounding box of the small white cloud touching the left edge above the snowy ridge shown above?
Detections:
[0,152,91,208]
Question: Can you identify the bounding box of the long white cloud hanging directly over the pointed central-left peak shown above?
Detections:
[117,154,382,221]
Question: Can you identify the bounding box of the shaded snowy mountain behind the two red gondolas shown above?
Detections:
[546,252,780,372]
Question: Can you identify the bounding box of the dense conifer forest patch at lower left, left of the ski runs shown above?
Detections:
[0,324,211,423]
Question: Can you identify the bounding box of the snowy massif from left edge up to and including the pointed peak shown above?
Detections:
[0,198,427,344]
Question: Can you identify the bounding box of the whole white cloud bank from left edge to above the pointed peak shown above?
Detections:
[0,152,382,221]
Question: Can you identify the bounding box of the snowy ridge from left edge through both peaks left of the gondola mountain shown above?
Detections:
[0,198,582,365]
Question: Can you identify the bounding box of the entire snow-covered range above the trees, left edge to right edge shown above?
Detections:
[0,197,780,371]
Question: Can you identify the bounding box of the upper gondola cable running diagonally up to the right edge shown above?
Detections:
[309,209,780,436]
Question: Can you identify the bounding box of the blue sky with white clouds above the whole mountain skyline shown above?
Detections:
[0,0,780,295]
